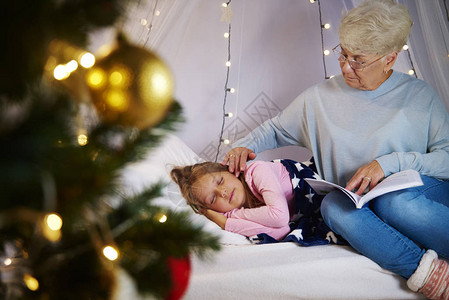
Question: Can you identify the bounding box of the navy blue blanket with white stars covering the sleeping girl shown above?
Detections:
[248,157,347,246]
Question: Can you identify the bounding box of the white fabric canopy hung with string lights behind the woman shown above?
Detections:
[88,0,449,161]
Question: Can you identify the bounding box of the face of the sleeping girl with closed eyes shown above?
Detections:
[195,171,246,213]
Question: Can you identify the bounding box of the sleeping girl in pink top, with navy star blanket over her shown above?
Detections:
[171,159,342,246]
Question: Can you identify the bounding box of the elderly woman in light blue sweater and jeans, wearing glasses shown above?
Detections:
[223,0,449,299]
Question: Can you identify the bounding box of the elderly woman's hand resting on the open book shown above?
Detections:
[346,161,385,195]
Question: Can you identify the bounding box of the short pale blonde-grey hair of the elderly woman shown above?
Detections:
[338,0,413,55]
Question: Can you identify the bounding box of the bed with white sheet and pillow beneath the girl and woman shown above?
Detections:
[116,135,425,300]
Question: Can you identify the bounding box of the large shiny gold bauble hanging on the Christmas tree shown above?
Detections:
[86,37,174,129]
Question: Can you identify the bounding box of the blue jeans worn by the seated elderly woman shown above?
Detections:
[321,176,449,278]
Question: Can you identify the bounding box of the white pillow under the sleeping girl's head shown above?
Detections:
[120,134,250,245]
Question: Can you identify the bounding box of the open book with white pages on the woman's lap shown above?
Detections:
[305,170,423,208]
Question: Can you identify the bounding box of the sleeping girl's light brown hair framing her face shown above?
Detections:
[170,162,264,213]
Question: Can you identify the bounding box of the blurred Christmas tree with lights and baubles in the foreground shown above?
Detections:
[0,0,219,300]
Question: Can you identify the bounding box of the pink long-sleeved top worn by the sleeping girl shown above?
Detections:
[224,161,295,240]
